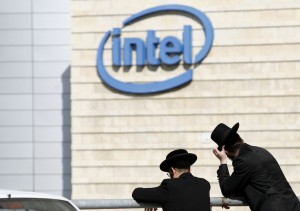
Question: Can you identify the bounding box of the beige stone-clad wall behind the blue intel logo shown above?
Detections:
[71,0,300,209]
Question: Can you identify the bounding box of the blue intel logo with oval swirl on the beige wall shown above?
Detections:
[97,5,214,94]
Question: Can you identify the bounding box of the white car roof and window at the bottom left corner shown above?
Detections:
[0,189,79,211]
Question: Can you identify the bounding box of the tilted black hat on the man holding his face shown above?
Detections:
[210,123,240,151]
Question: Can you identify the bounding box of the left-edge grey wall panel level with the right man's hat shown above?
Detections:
[0,127,33,142]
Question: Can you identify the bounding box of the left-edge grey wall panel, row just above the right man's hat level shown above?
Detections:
[0,111,33,126]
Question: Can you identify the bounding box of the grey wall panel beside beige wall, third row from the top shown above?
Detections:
[33,29,71,45]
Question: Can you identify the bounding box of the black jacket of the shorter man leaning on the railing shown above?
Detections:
[132,173,210,211]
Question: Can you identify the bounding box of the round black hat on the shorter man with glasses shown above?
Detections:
[160,149,197,172]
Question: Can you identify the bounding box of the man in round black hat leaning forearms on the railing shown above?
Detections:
[132,149,210,211]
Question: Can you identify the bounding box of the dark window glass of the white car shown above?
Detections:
[0,198,77,211]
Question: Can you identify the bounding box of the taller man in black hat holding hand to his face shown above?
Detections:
[211,123,300,211]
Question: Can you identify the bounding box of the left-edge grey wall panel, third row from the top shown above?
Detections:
[0,30,32,46]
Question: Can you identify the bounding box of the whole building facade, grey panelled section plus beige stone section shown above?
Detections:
[0,0,300,210]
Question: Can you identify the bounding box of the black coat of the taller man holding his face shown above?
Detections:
[217,144,300,211]
